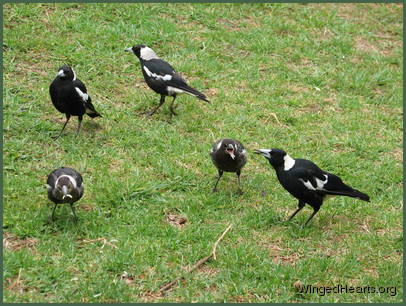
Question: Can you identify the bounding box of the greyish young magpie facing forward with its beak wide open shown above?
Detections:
[210,138,247,193]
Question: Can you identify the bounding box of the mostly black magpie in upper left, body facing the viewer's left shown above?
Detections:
[49,65,102,139]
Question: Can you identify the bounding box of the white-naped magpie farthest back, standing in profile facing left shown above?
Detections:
[125,45,210,116]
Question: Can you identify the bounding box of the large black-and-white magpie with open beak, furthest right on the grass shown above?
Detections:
[255,149,369,226]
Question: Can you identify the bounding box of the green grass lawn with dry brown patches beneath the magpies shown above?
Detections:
[3,4,403,303]
